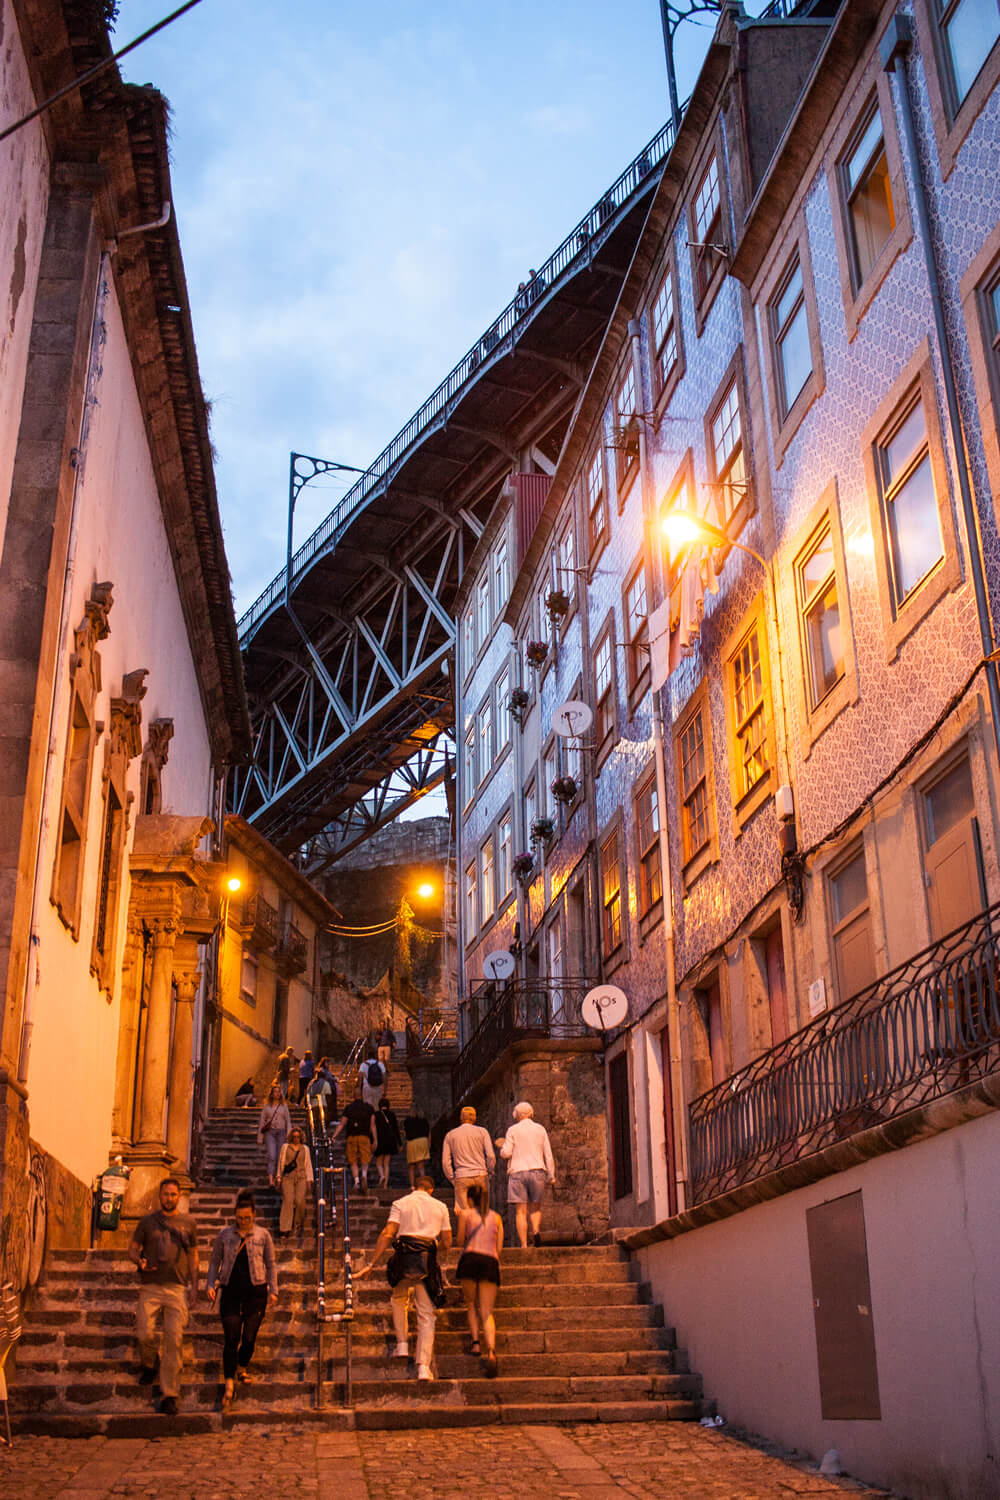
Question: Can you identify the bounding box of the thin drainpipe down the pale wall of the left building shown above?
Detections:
[18,251,111,1085]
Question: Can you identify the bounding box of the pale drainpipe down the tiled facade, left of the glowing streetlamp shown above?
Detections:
[628,318,688,1215]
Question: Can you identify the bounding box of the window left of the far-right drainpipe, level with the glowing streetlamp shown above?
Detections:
[876,396,945,609]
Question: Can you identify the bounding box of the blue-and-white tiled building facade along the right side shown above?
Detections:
[459,0,1000,1496]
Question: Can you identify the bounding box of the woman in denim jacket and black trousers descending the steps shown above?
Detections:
[205,1188,277,1412]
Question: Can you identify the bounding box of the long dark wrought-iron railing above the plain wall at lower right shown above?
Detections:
[690,903,1000,1203]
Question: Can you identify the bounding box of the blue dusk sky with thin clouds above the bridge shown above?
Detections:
[114,0,743,614]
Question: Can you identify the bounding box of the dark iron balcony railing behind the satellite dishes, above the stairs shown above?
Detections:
[451,980,592,1103]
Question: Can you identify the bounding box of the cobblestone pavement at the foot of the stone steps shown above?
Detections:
[0,1422,882,1500]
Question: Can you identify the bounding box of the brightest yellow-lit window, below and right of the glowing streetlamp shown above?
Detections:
[724,603,774,828]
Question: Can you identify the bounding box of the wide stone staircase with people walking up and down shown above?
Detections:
[10,1104,705,1436]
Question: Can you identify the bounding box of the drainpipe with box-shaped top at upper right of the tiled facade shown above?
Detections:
[879,12,1000,762]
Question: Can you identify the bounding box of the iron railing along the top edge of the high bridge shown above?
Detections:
[237,114,673,645]
